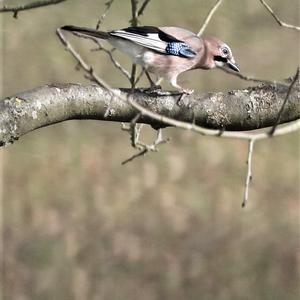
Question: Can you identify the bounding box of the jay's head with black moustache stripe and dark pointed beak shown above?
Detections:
[204,37,240,72]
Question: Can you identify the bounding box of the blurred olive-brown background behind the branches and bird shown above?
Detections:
[0,0,300,300]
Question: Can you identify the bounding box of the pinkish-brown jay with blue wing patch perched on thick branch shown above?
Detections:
[61,25,239,94]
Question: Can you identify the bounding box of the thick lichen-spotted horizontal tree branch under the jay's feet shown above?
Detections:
[0,77,300,145]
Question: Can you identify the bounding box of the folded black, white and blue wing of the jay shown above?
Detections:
[109,26,196,57]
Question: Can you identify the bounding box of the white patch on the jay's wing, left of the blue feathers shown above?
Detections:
[110,30,168,54]
